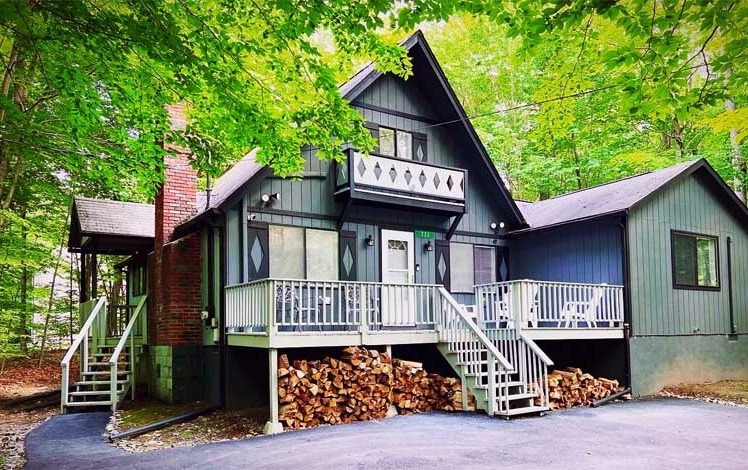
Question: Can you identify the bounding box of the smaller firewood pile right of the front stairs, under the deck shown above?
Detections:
[548,367,623,410]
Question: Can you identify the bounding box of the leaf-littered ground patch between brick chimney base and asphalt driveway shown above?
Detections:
[107,401,267,452]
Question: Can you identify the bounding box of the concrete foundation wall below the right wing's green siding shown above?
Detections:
[630,335,748,396]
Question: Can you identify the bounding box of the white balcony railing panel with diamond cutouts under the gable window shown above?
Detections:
[336,152,467,204]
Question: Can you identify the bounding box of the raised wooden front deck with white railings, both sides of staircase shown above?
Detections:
[226,279,623,348]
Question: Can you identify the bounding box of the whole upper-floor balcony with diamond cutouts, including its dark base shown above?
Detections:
[335,149,467,214]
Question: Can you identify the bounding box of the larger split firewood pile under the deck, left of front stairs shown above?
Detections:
[278,347,470,429]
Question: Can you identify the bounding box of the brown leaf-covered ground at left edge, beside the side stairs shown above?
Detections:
[0,351,70,470]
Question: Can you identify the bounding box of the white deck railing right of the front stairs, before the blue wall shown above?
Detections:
[475,280,623,330]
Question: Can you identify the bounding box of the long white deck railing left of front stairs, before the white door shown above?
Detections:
[226,279,440,334]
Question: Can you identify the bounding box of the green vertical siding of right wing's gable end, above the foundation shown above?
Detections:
[629,174,748,335]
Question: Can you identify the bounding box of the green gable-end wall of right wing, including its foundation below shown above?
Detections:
[628,173,748,395]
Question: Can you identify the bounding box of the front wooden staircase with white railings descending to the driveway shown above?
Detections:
[438,289,553,418]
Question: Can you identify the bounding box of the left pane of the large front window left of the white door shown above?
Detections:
[268,225,304,279]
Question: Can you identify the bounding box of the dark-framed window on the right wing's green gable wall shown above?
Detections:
[671,231,719,290]
